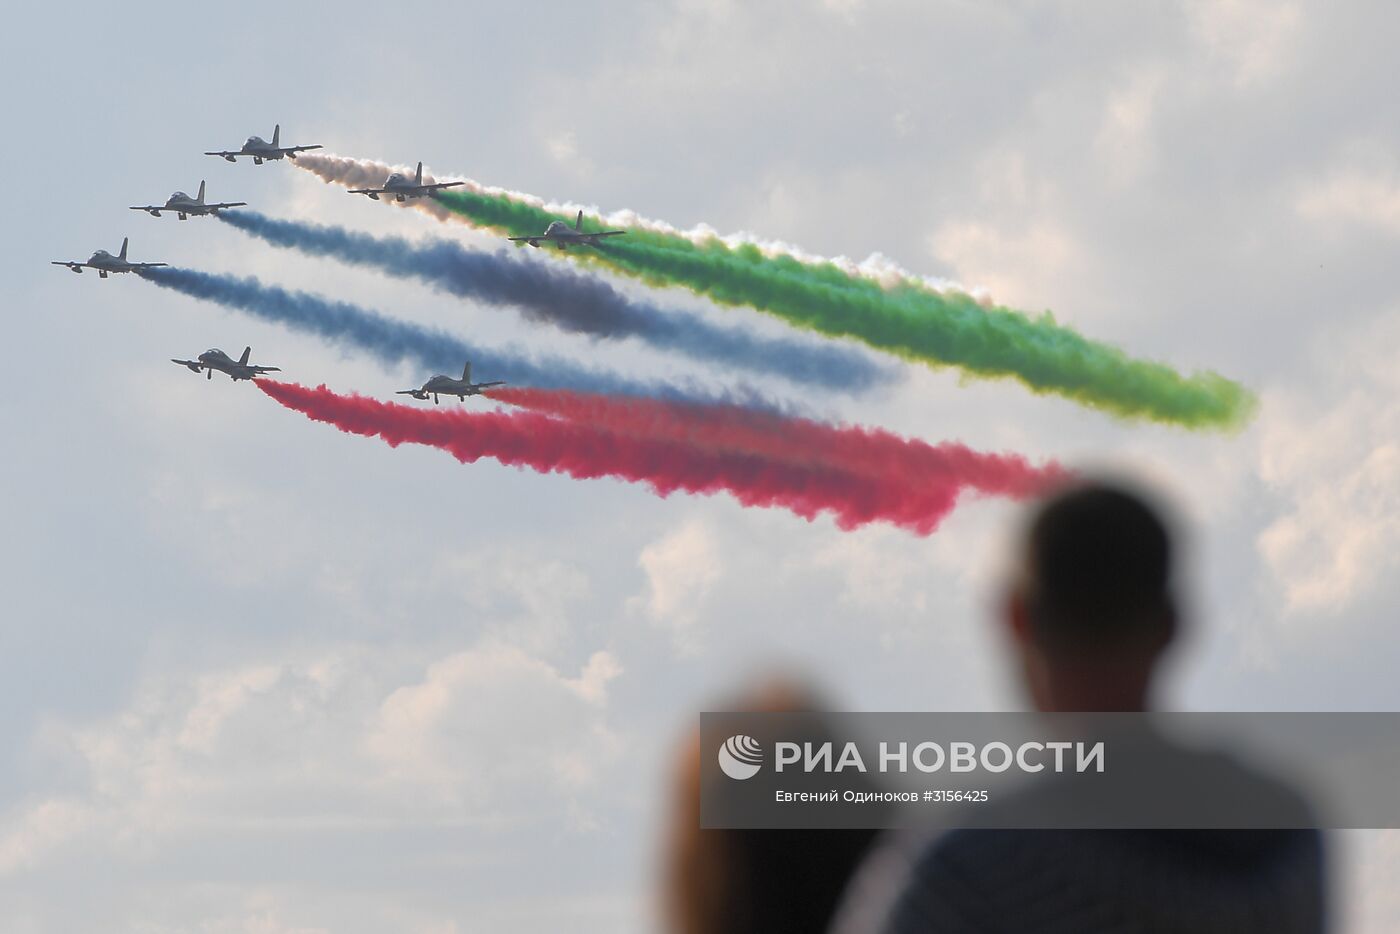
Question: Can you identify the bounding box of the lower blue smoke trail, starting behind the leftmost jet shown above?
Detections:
[137,266,777,409]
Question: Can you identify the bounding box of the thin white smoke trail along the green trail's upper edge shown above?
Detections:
[287,153,990,302]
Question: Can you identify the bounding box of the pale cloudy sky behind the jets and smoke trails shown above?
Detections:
[0,0,1400,934]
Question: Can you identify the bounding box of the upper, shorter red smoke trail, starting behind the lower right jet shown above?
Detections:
[487,388,1067,499]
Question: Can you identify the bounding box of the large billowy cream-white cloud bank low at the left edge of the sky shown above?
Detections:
[0,644,622,874]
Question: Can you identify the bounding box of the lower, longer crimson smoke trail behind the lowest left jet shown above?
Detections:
[256,379,1030,535]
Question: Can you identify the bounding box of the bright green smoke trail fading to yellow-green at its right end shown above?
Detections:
[438,189,1256,428]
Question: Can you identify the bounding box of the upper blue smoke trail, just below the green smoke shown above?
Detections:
[218,211,895,392]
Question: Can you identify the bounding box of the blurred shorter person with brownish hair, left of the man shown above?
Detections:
[662,678,876,934]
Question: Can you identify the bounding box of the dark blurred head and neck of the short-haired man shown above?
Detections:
[1007,483,1176,710]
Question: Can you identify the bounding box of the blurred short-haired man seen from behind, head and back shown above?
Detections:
[834,480,1326,934]
